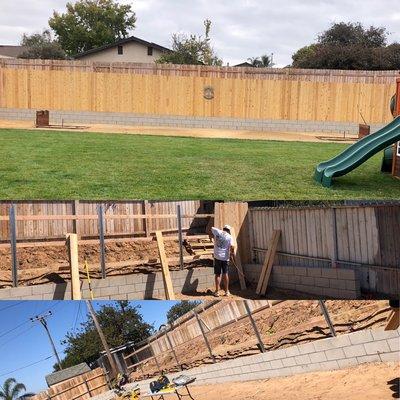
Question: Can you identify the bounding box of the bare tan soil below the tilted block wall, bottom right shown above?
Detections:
[186,363,400,400]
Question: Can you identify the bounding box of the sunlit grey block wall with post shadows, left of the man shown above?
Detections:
[0,267,214,300]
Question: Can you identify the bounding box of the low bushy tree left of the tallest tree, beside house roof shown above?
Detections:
[19,29,66,60]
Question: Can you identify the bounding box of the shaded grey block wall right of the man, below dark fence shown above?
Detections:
[243,264,361,299]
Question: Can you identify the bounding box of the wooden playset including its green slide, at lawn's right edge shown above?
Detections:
[314,78,400,187]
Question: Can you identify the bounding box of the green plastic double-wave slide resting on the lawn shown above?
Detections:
[314,116,400,187]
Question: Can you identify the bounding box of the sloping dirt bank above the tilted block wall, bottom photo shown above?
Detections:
[132,300,390,380]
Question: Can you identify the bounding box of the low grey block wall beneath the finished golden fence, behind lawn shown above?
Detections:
[0,108,382,134]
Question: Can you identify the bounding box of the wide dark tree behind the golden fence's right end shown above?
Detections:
[292,22,400,70]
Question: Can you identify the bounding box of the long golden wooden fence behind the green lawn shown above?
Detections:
[0,60,397,124]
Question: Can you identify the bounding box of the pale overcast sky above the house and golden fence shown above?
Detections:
[0,0,400,66]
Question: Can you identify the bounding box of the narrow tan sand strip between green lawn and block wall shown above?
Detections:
[0,120,357,143]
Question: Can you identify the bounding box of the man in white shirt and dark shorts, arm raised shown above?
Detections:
[211,225,234,297]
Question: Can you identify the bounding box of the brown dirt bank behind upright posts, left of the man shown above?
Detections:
[0,240,212,287]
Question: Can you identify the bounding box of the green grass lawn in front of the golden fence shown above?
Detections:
[0,129,400,200]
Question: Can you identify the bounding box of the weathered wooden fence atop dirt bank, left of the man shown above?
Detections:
[0,200,211,242]
